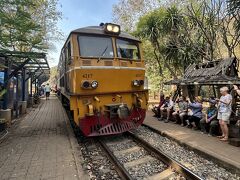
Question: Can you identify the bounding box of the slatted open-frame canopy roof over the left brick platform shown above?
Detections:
[0,50,50,83]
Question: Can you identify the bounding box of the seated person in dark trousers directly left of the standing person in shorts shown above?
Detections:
[200,101,218,136]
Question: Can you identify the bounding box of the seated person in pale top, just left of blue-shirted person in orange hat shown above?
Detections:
[172,96,188,126]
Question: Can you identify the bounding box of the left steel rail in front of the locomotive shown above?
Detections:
[97,138,133,180]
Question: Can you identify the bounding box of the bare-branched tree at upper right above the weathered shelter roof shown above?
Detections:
[186,0,240,58]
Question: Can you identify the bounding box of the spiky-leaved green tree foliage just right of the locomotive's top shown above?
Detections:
[135,6,202,78]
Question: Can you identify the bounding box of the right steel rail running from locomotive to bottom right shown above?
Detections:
[126,131,203,180]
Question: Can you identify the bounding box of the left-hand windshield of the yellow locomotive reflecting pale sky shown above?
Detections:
[78,36,113,58]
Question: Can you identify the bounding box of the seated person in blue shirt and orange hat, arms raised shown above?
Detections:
[187,96,202,130]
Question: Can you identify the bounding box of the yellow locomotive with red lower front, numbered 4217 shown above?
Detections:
[58,23,148,136]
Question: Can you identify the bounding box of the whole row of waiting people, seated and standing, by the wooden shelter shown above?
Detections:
[153,85,240,141]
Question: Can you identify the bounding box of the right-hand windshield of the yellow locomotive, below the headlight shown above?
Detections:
[117,39,140,60]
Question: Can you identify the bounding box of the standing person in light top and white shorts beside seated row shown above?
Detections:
[216,87,232,141]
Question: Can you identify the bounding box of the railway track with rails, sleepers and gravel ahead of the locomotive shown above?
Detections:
[97,132,202,180]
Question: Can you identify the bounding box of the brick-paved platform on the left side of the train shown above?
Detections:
[0,96,88,180]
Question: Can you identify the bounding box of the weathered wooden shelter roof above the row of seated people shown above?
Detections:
[165,57,240,85]
